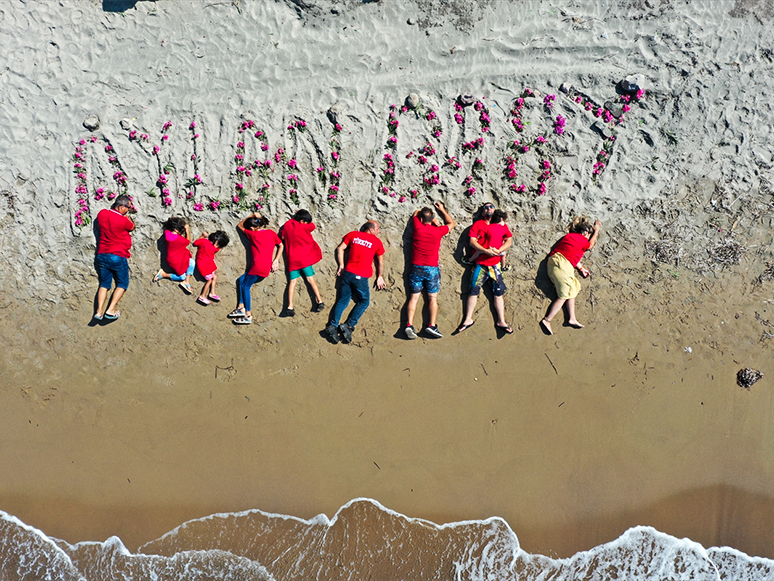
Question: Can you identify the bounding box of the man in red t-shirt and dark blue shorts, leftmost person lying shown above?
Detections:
[94,194,134,321]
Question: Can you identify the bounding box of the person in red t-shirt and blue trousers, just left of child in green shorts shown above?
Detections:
[228,212,282,325]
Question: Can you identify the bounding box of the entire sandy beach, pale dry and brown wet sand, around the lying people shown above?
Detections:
[0,0,774,579]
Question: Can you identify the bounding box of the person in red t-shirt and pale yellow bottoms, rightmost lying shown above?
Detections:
[540,216,602,335]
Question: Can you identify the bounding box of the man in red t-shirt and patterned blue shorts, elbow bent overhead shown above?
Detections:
[404,202,457,339]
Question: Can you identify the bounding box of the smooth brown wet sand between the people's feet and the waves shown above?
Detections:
[0,258,774,557]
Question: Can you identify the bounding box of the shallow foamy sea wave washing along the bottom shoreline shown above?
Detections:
[0,498,774,581]
